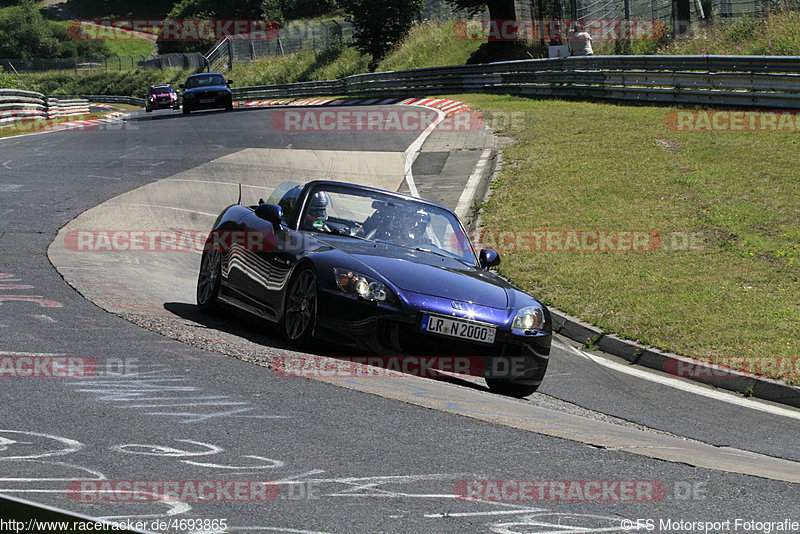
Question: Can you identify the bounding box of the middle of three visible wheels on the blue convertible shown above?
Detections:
[283,266,317,346]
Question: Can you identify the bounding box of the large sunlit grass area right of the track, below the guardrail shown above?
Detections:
[454,95,800,382]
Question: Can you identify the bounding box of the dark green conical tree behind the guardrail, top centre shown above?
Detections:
[339,0,422,72]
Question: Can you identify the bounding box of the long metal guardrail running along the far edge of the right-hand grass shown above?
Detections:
[228,56,800,109]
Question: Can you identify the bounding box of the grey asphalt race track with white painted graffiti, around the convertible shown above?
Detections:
[0,110,800,533]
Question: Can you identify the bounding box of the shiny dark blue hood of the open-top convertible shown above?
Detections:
[324,238,509,308]
